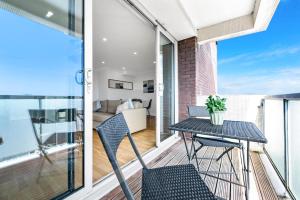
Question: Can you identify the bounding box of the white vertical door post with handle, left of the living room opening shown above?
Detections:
[66,0,93,200]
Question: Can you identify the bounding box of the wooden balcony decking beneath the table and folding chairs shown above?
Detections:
[102,141,277,200]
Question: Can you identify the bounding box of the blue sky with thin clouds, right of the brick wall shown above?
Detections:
[218,0,300,94]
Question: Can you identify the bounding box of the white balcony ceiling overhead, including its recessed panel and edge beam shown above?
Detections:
[132,0,279,43]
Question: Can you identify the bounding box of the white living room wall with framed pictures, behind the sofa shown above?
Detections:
[93,69,156,116]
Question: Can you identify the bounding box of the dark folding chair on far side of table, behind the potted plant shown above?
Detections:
[188,105,245,180]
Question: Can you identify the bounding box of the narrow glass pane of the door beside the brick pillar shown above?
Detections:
[158,34,175,142]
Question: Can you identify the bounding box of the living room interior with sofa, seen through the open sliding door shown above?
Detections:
[93,0,156,182]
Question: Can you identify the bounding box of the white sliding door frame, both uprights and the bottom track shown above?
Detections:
[66,1,178,200]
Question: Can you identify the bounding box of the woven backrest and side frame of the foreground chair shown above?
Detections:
[96,113,147,200]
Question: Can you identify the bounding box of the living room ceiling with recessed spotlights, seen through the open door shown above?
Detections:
[93,0,155,74]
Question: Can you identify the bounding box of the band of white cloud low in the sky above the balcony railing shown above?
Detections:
[218,66,300,95]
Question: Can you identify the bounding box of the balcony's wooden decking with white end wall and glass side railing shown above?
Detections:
[102,94,300,199]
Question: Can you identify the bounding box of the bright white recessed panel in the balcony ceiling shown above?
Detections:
[179,0,255,29]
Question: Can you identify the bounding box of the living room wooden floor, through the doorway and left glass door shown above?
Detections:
[0,124,155,200]
